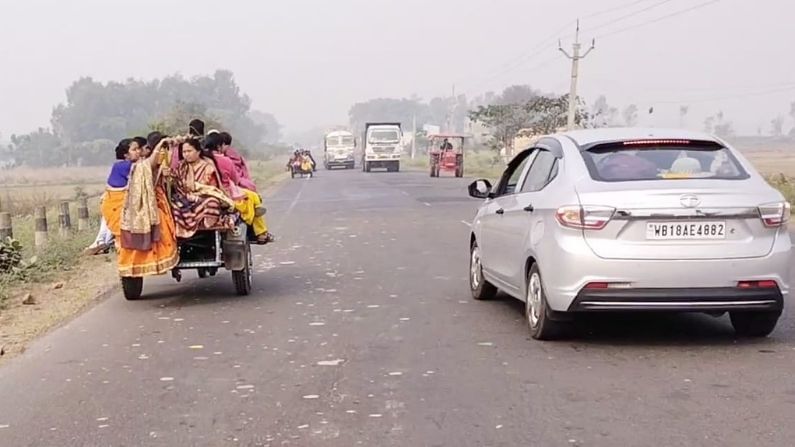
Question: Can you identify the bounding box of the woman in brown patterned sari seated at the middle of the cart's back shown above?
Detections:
[171,138,235,239]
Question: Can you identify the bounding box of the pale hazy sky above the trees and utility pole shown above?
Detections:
[0,0,795,137]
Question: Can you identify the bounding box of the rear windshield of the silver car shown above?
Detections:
[582,142,748,182]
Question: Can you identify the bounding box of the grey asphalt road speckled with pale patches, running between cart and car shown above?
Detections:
[0,171,795,447]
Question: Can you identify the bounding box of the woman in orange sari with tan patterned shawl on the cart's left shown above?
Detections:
[102,136,179,277]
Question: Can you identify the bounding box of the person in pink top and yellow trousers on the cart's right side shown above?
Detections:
[204,133,275,244]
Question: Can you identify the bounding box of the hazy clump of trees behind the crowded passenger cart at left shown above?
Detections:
[0,70,281,167]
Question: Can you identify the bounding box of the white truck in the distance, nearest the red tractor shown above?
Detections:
[362,123,403,172]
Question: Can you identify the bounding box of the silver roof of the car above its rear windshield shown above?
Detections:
[557,127,720,146]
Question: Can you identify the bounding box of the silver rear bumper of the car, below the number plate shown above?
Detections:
[537,231,793,312]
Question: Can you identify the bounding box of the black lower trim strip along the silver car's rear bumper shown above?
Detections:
[568,287,784,312]
